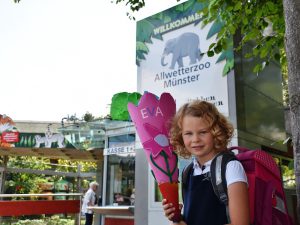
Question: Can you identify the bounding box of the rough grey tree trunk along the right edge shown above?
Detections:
[283,0,300,218]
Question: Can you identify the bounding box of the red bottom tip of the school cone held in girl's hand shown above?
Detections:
[158,182,181,222]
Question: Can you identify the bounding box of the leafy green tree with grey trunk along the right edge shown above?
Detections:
[116,0,300,218]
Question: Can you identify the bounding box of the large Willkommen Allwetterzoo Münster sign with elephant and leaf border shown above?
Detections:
[136,0,233,116]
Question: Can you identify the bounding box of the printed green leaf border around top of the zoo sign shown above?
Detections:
[136,0,234,75]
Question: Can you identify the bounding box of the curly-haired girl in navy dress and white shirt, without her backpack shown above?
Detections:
[162,100,250,225]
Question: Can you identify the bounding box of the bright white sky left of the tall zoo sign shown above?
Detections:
[0,0,182,121]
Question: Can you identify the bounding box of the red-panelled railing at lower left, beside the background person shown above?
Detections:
[0,193,83,225]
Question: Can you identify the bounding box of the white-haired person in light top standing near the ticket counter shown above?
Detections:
[81,182,99,225]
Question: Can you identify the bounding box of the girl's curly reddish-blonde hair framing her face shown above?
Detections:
[170,100,234,158]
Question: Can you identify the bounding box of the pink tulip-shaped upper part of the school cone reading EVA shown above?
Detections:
[128,92,178,183]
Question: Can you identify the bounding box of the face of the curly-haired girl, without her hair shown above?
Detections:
[182,116,216,165]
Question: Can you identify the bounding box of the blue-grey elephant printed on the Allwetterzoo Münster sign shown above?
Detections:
[161,32,202,69]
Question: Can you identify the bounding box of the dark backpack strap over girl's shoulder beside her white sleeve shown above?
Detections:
[210,151,237,206]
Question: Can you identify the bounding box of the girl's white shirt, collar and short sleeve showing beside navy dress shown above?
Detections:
[193,158,248,187]
